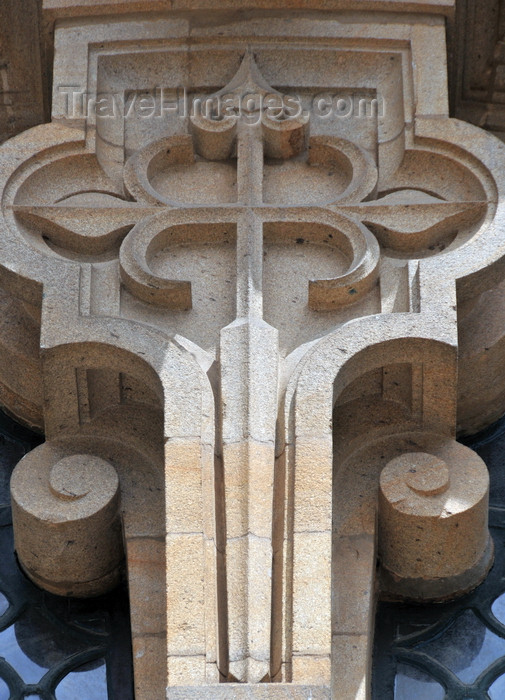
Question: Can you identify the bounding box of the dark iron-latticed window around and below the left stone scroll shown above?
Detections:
[0,414,133,700]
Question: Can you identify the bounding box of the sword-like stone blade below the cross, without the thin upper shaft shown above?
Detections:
[220,318,277,683]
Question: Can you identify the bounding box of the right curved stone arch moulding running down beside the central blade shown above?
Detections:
[281,314,457,697]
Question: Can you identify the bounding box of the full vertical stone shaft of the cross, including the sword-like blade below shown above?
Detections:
[220,123,278,683]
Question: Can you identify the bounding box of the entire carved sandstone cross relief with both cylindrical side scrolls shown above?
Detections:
[0,6,505,700]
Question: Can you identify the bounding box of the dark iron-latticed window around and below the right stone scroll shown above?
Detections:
[372,418,505,700]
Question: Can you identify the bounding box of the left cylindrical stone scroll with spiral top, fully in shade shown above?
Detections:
[11,445,124,598]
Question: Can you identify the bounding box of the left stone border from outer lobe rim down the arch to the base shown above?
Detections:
[0,119,222,684]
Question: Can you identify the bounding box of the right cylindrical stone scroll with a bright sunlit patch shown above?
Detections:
[379,441,493,600]
